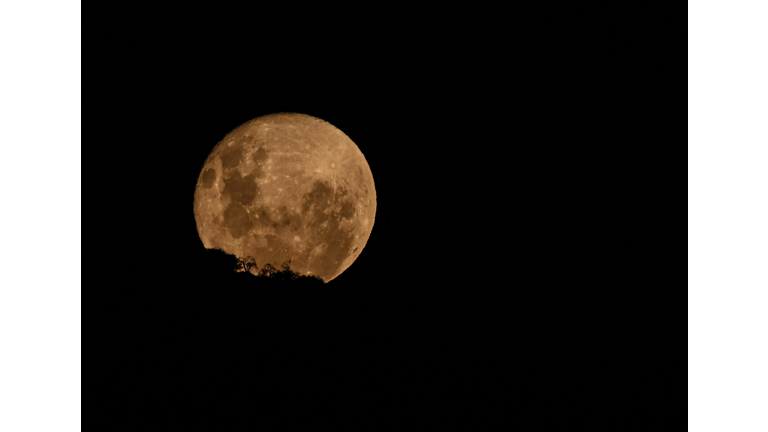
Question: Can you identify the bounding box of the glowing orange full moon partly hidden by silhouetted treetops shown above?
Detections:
[194,113,376,282]
